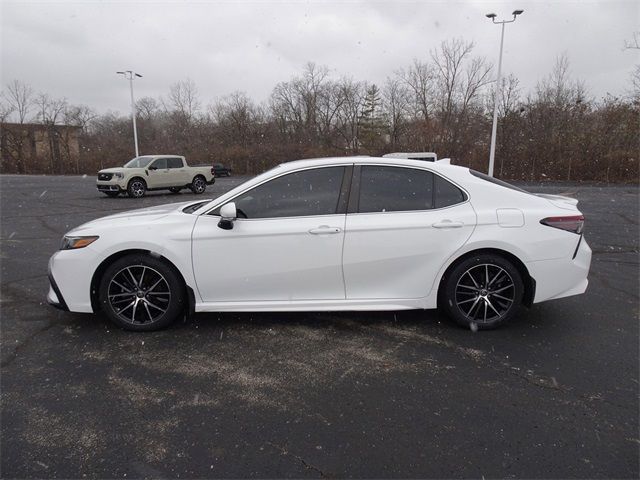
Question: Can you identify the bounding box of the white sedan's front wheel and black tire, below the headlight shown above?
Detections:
[98,253,187,332]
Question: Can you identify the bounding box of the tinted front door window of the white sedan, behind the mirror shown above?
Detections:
[228,167,345,218]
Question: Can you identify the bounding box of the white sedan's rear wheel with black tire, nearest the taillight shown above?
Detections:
[438,253,524,330]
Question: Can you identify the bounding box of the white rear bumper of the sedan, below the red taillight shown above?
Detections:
[527,238,591,303]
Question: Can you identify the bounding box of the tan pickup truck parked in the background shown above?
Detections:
[96,155,216,198]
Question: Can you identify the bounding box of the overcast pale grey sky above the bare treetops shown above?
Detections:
[0,0,640,113]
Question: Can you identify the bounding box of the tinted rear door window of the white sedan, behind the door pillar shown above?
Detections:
[358,165,433,213]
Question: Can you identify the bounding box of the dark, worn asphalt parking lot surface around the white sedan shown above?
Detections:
[0,176,640,478]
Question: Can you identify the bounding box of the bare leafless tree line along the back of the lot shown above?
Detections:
[0,39,640,182]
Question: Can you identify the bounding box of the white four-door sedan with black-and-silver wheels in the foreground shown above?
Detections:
[47,157,591,330]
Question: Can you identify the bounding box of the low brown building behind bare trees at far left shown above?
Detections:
[0,123,81,173]
